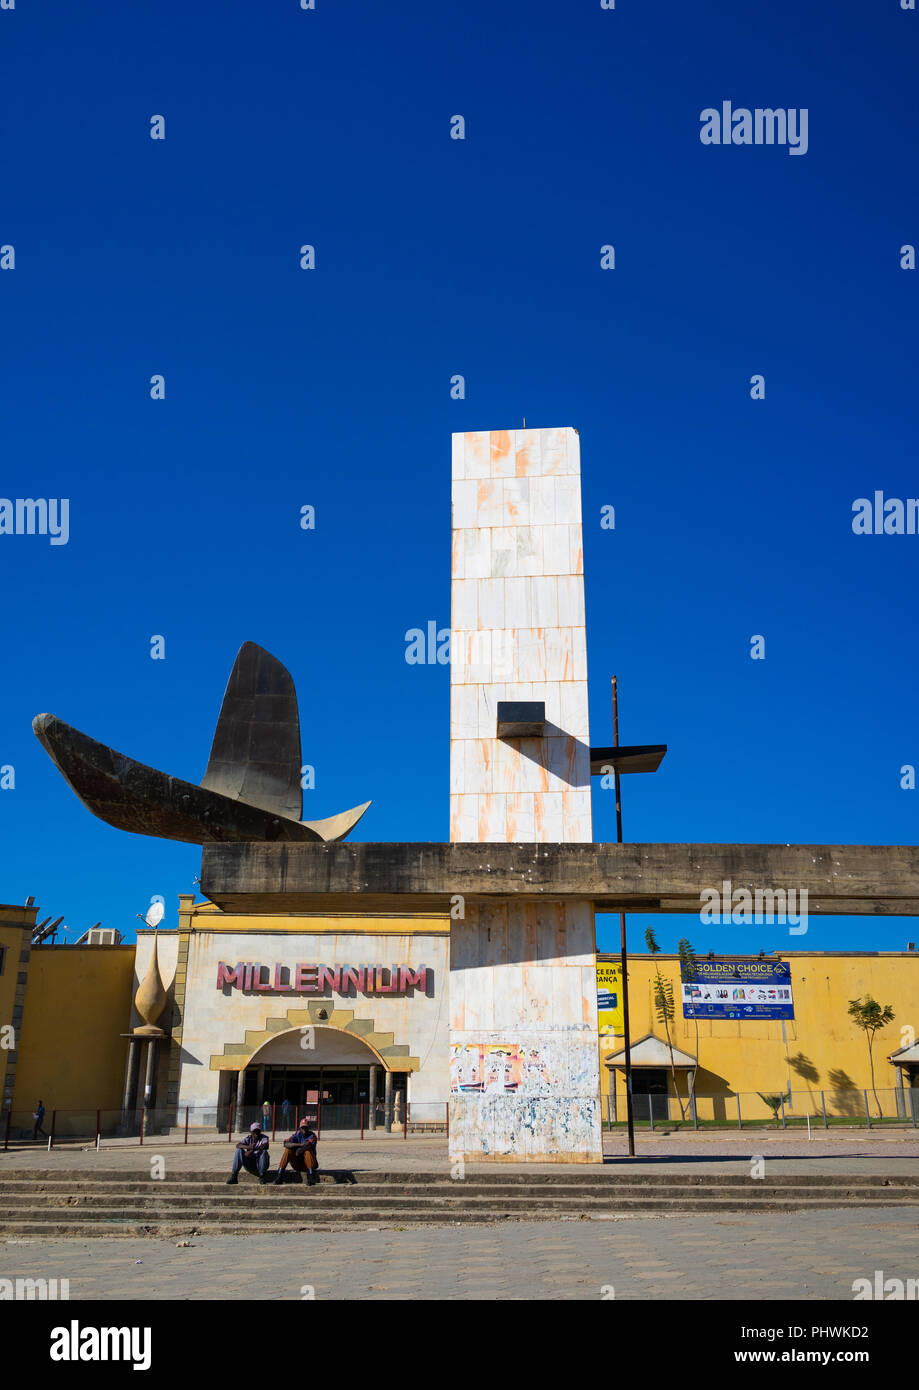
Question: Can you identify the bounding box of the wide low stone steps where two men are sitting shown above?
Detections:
[0,1168,919,1240]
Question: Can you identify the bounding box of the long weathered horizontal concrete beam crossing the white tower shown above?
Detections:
[202,841,919,917]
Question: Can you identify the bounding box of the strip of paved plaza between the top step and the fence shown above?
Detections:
[0,1129,919,1177]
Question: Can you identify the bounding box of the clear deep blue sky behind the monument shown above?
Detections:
[0,0,919,951]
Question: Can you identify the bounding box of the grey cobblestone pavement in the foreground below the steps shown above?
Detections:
[0,1208,919,1301]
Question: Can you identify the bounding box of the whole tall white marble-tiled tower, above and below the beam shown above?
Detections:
[450,428,602,1162]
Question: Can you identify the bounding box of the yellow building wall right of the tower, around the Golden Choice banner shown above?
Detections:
[598,951,919,1123]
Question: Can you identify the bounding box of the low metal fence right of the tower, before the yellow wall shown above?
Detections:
[603,1086,919,1130]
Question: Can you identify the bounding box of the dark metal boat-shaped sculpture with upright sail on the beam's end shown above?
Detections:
[32,642,370,845]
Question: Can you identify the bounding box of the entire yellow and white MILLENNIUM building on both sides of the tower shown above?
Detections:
[0,895,919,1138]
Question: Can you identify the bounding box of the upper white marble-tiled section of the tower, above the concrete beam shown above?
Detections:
[450,430,592,841]
